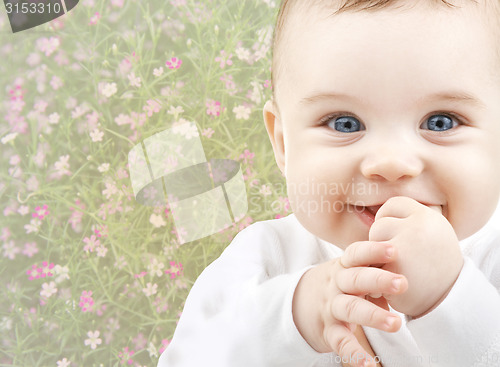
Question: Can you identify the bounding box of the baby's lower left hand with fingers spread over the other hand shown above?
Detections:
[292,241,408,366]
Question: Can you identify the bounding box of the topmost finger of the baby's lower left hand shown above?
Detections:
[340,241,396,268]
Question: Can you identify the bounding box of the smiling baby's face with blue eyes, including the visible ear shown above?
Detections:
[264,2,500,248]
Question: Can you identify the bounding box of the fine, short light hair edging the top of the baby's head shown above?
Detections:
[271,0,500,112]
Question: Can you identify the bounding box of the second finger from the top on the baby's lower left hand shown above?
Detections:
[335,267,407,296]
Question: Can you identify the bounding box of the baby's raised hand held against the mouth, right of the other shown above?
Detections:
[369,196,463,317]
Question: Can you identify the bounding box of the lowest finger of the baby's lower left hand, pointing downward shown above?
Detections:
[326,324,375,367]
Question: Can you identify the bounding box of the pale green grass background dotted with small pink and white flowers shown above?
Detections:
[0,0,289,367]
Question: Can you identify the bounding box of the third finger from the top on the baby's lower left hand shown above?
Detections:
[331,294,401,332]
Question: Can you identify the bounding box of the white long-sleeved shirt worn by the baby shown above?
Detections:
[158,205,500,367]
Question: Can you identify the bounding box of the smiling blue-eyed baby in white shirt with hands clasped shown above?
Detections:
[159,0,500,367]
